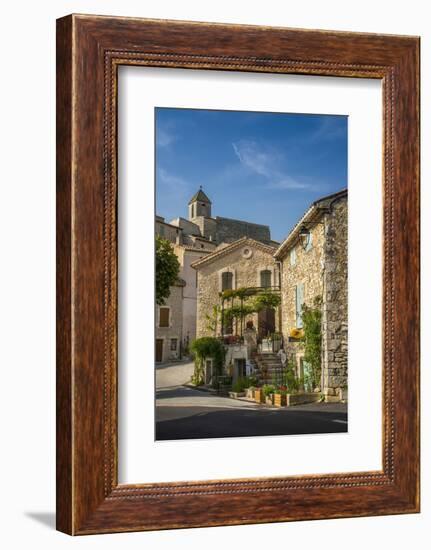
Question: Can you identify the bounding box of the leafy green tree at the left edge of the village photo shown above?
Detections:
[156,235,180,306]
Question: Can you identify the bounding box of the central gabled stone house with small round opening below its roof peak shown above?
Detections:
[192,237,281,382]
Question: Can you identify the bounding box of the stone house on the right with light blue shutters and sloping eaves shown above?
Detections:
[274,190,348,401]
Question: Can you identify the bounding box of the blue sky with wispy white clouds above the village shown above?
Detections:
[156,108,347,241]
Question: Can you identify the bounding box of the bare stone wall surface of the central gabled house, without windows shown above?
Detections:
[196,244,278,338]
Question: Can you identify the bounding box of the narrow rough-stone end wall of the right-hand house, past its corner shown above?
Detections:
[322,198,348,401]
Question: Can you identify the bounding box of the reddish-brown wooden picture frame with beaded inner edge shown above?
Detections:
[57,15,419,535]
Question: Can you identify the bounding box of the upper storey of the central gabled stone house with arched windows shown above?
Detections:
[192,237,281,338]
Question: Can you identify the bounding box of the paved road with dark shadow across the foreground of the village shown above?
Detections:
[156,363,347,440]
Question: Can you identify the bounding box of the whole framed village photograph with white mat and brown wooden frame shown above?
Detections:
[57,15,419,535]
